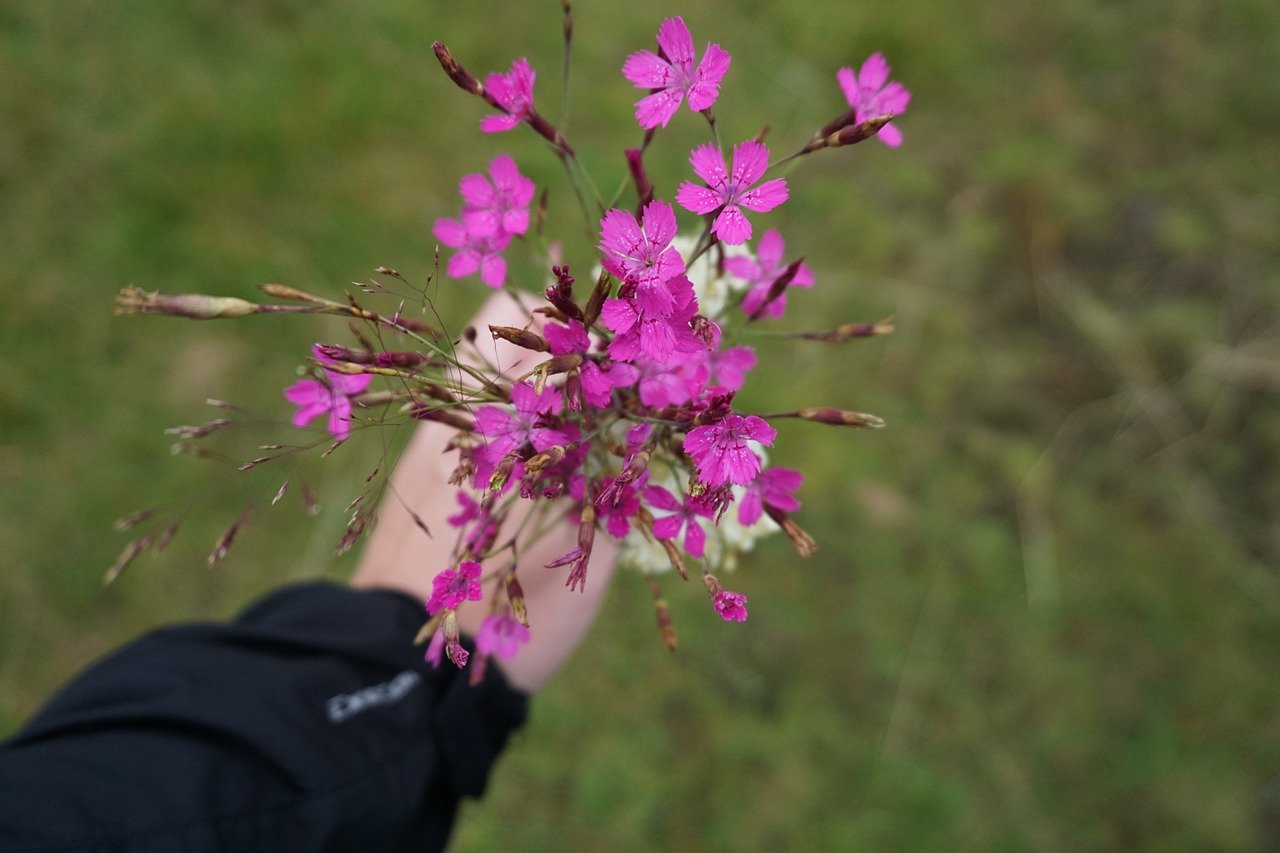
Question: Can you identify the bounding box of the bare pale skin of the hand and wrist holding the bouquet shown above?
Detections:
[351,295,618,693]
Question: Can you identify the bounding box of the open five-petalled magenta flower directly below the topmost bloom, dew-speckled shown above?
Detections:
[676,140,787,246]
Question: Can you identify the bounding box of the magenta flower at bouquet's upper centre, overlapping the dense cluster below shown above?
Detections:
[600,201,685,314]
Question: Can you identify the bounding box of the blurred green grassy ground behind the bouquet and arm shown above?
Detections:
[0,0,1280,850]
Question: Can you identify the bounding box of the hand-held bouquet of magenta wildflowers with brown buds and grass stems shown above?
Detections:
[109,9,910,666]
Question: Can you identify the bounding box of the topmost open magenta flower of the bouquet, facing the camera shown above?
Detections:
[622,18,730,131]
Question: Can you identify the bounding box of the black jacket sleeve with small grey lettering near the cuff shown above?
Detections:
[0,583,526,853]
